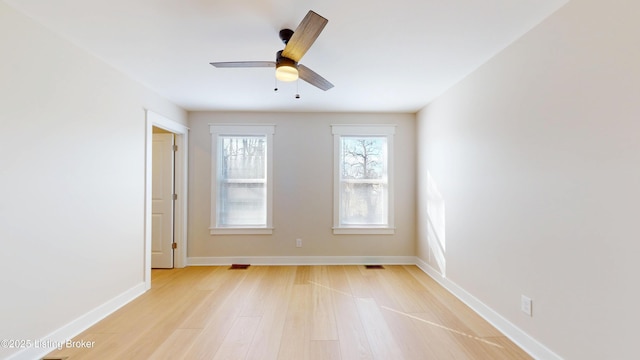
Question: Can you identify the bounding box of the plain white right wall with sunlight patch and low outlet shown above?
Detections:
[418,0,640,359]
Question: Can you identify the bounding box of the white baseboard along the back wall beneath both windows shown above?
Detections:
[187,256,416,266]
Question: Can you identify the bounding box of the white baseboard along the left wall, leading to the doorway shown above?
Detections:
[7,283,147,360]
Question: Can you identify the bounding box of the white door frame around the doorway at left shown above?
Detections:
[143,109,189,290]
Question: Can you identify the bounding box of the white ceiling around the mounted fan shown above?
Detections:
[5,0,567,112]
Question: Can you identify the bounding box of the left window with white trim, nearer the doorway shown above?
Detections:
[209,125,275,235]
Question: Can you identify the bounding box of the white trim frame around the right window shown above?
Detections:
[331,124,396,235]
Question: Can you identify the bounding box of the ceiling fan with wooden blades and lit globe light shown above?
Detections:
[210,10,333,91]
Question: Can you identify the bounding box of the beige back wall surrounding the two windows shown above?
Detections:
[188,112,415,258]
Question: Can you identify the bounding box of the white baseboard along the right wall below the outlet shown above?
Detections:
[416,258,562,360]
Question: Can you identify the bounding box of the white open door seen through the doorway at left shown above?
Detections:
[151,133,174,269]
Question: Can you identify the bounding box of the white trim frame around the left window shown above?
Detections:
[209,124,275,235]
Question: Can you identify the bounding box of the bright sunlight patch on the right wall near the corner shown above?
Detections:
[427,172,447,277]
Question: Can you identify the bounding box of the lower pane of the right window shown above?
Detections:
[340,182,387,226]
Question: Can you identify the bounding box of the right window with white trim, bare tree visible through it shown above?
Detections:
[332,125,395,234]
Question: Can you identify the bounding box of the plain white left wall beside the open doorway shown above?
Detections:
[0,2,186,358]
